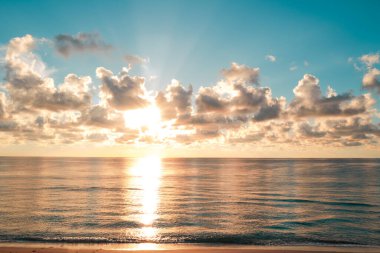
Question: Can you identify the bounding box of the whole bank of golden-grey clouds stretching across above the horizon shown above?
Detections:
[0,35,380,148]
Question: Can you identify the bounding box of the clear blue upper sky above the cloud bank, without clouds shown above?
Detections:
[0,0,380,99]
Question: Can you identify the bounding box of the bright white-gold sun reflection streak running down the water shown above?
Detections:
[127,156,162,250]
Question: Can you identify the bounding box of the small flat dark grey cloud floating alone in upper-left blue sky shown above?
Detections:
[54,33,112,57]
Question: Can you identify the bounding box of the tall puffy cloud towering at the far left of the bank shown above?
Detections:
[5,35,91,113]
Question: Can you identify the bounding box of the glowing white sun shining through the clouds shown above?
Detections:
[124,106,161,130]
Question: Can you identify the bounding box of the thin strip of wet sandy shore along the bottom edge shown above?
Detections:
[0,244,380,253]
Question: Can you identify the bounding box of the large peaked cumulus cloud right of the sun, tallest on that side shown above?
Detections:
[195,63,283,122]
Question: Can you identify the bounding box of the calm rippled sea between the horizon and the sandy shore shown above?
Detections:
[0,157,380,245]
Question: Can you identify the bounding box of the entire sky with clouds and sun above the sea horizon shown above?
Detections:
[0,0,380,157]
